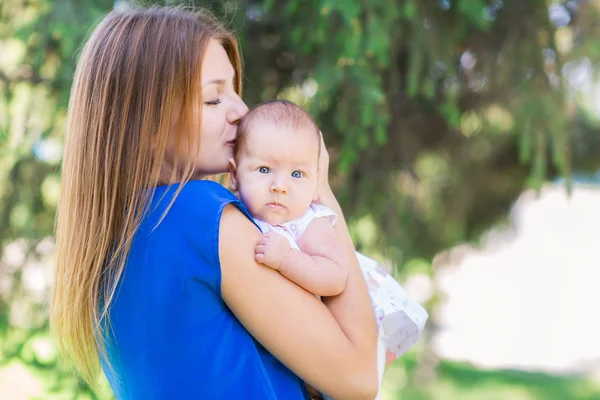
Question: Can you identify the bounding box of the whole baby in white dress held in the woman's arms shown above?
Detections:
[229,100,427,396]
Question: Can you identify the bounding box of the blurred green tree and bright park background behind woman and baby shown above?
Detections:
[0,0,600,400]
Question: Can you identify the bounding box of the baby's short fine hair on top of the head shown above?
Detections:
[233,100,321,161]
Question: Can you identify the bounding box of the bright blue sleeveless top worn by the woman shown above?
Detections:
[101,181,309,400]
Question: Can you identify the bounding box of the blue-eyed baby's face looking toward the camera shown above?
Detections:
[231,123,319,225]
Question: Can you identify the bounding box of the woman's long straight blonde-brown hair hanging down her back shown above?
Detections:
[50,7,242,385]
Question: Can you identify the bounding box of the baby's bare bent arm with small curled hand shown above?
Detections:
[256,218,348,296]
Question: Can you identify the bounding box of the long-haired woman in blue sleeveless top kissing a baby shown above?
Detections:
[51,8,378,400]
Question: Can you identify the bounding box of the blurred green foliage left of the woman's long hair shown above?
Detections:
[0,0,113,399]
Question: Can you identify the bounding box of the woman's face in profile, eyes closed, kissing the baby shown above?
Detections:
[163,39,248,178]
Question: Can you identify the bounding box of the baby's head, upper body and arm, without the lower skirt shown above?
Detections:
[230,101,347,296]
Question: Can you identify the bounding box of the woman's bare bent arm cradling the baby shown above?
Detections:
[219,205,378,399]
